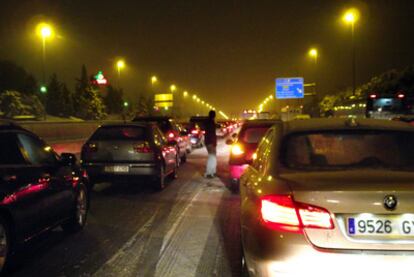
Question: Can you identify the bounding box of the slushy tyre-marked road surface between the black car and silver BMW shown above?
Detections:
[8,141,240,276]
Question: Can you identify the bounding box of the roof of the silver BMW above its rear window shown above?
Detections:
[283,118,414,134]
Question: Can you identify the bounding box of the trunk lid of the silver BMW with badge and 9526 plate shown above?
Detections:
[280,170,414,250]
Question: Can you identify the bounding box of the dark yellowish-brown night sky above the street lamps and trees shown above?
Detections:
[0,0,414,113]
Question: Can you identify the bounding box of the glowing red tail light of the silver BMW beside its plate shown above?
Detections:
[260,195,334,232]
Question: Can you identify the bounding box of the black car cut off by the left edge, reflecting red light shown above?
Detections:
[0,121,89,271]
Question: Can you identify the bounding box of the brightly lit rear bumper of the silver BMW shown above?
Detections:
[242,224,414,277]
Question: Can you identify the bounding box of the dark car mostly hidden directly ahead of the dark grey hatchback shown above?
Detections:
[133,116,190,165]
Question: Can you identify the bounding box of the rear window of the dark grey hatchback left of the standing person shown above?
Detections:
[91,126,147,140]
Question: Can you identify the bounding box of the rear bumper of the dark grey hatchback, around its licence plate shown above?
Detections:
[82,163,160,179]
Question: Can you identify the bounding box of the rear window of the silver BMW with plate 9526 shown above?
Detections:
[282,130,414,170]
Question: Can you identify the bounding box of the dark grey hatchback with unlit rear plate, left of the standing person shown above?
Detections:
[81,122,178,190]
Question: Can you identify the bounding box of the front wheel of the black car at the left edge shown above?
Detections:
[62,184,89,233]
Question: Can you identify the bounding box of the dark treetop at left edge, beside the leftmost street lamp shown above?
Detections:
[0,61,38,94]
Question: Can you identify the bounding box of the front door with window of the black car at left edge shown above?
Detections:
[17,132,76,226]
